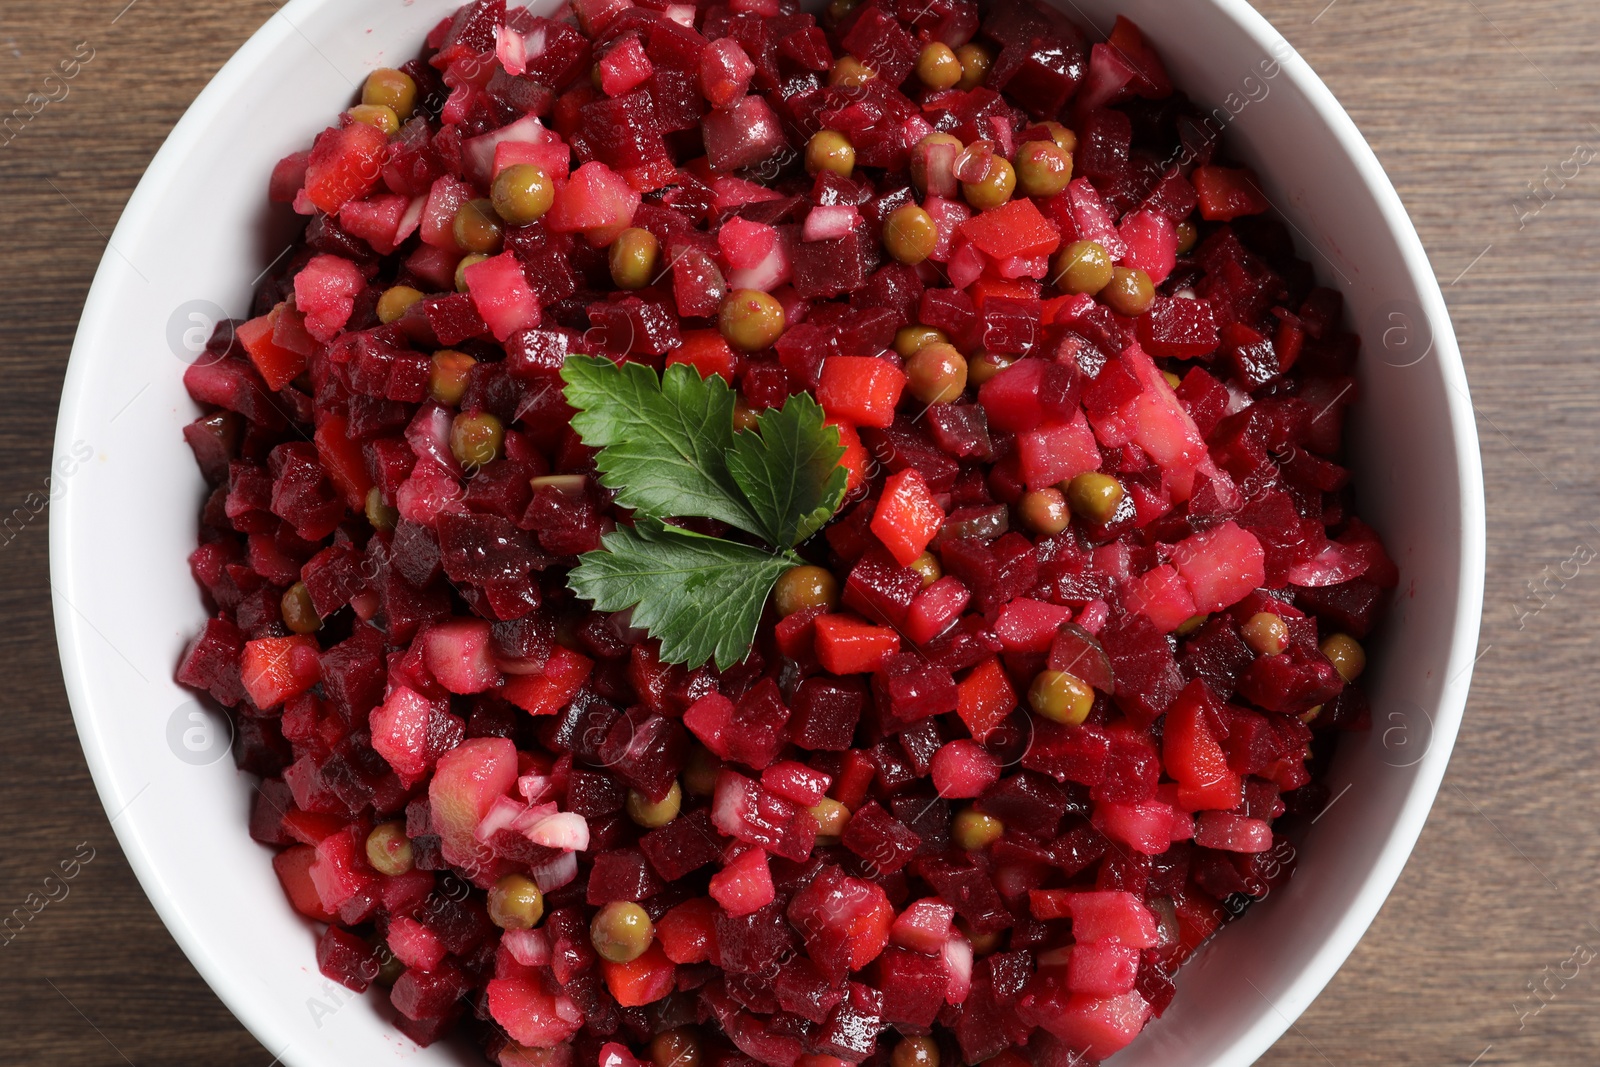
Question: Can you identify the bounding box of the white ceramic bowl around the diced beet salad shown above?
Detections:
[51,0,1485,1067]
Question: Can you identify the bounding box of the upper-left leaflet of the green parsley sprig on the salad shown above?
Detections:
[562,355,761,547]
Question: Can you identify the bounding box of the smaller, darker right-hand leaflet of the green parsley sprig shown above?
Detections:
[728,394,848,547]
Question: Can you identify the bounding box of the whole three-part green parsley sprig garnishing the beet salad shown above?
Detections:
[562,355,848,669]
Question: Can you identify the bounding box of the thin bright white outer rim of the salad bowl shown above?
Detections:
[50,0,1486,1064]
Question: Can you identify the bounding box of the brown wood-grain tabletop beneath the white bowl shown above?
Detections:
[0,0,1600,1067]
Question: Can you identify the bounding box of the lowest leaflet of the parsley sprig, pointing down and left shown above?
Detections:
[568,520,800,670]
